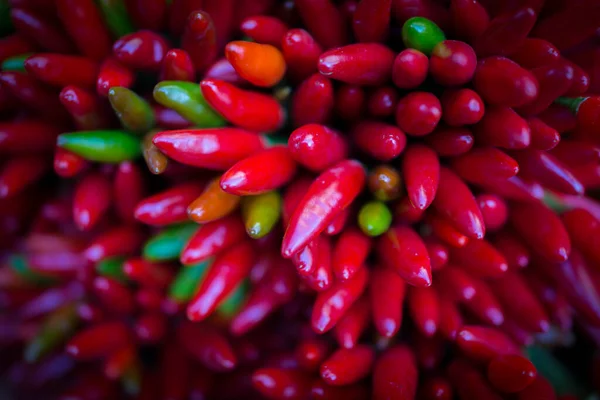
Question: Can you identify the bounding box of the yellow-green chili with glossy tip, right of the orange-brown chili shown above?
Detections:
[242,191,281,239]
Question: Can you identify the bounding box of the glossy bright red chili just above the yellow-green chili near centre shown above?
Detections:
[220,146,296,196]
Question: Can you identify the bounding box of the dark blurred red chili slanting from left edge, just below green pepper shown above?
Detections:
[0,71,69,124]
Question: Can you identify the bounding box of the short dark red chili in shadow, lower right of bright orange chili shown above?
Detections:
[291,74,334,127]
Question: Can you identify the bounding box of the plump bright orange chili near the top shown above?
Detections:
[225,40,286,87]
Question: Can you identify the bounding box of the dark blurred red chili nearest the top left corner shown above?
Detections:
[10,8,75,54]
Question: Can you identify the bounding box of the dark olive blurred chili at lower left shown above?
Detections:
[24,305,79,363]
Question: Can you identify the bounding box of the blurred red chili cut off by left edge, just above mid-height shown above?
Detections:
[0,156,50,199]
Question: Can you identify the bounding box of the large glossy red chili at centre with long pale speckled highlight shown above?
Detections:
[281,160,366,257]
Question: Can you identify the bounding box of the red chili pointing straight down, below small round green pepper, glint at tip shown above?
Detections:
[369,267,405,338]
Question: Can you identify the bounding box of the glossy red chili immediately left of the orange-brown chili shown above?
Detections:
[134,183,204,226]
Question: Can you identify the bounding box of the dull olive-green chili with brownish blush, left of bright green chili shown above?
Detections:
[108,86,155,133]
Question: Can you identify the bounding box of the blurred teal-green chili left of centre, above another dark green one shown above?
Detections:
[143,224,198,261]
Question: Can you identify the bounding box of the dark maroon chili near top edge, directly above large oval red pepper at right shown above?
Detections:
[473,7,537,57]
